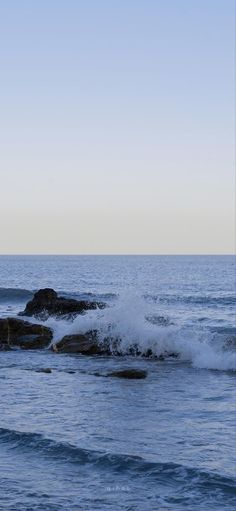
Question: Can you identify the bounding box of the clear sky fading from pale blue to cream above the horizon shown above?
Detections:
[0,0,235,254]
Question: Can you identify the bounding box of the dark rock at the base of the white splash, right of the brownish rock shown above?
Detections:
[52,331,104,355]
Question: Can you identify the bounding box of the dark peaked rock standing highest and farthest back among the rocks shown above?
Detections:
[19,288,105,316]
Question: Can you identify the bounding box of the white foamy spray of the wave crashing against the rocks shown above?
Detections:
[44,292,236,371]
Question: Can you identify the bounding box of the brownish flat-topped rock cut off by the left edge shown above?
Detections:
[0,318,53,350]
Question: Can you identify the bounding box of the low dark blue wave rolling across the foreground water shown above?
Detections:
[0,428,236,494]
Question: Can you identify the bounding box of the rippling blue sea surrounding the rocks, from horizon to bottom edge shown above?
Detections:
[0,256,236,511]
